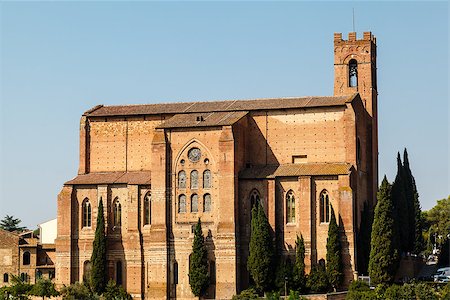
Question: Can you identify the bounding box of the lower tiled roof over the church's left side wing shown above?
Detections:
[65,171,151,185]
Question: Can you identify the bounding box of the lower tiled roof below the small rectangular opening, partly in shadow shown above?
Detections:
[239,163,351,179]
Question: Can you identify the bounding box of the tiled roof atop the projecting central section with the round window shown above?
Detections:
[157,111,248,128]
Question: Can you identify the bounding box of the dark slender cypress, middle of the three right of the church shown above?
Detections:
[391,153,411,253]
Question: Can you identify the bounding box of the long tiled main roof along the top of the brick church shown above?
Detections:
[84,94,357,117]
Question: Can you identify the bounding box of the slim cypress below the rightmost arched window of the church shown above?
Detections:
[326,207,344,291]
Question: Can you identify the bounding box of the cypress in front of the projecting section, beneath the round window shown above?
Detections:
[189,218,209,297]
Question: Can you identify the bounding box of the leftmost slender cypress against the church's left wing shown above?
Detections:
[91,199,107,294]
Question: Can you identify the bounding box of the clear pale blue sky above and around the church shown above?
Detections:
[0,1,450,228]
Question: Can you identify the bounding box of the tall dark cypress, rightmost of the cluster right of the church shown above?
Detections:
[403,148,425,254]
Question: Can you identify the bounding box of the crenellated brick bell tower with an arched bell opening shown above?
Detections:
[334,32,378,204]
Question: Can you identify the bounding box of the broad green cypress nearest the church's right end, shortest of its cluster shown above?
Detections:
[369,176,398,284]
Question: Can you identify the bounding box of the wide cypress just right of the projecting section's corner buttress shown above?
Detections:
[247,203,274,292]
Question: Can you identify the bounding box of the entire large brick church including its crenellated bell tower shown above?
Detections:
[56,32,378,299]
